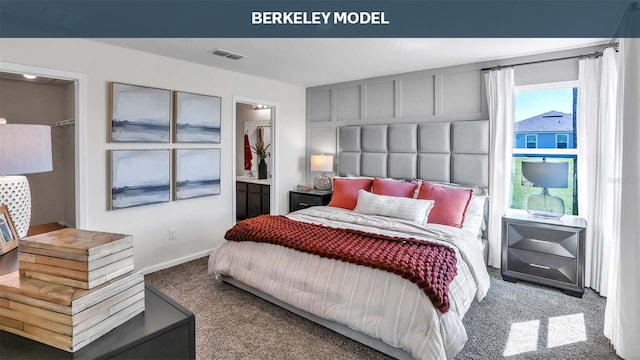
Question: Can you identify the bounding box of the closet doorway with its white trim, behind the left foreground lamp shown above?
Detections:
[0,62,87,228]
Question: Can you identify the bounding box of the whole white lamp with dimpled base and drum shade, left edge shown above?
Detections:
[0,122,55,238]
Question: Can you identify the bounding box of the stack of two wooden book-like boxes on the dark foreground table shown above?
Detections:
[0,229,144,352]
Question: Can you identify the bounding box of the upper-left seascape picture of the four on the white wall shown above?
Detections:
[109,82,171,143]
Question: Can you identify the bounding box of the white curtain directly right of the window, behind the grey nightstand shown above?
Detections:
[577,48,621,296]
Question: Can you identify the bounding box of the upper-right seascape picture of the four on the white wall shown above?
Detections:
[173,91,222,144]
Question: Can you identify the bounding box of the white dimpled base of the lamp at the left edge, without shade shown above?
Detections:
[0,176,31,238]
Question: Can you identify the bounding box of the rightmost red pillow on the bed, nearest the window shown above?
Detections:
[418,181,473,228]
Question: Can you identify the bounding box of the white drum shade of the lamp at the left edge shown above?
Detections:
[0,124,53,175]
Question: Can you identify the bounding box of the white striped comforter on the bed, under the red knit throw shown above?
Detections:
[209,207,489,359]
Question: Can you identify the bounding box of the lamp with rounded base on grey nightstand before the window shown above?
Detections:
[521,158,569,218]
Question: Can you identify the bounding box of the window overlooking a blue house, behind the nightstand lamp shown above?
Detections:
[511,81,579,215]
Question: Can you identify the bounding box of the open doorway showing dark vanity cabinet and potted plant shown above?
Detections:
[233,97,276,222]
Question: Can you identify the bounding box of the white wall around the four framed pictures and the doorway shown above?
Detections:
[0,39,305,269]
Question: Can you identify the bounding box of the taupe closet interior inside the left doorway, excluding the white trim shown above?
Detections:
[0,72,76,227]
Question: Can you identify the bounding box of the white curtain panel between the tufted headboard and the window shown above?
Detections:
[484,68,515,268]
